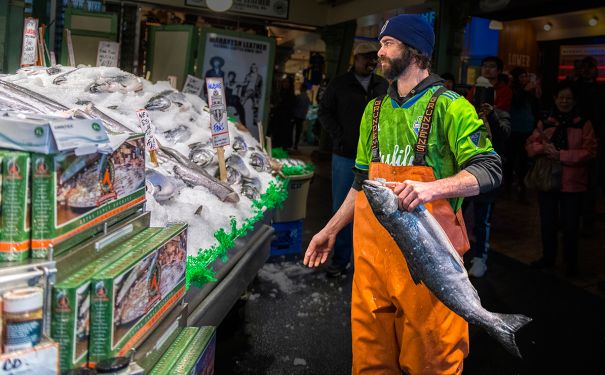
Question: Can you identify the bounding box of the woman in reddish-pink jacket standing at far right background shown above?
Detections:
[525,81,597,277]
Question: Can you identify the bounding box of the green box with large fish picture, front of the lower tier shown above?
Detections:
[89,224,187,363]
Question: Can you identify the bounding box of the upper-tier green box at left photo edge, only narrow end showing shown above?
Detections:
[0,151,31,262]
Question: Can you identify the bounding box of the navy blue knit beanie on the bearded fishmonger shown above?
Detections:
[378,14,435,57]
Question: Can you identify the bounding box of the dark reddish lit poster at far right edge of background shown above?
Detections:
[559,44,605,82]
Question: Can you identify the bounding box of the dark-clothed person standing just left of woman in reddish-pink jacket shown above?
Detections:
[504,67,538,202]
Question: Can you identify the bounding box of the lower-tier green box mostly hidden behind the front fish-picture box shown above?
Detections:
[51,228,161,371]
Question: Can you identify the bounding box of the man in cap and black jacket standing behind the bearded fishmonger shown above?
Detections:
[318,42,389,277]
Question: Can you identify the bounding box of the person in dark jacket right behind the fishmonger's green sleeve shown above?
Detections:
[464,56,512,277]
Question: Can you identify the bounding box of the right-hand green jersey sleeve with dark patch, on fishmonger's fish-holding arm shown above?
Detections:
[444,98,495,165]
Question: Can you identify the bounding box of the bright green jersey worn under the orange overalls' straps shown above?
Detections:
[355,86,495,211]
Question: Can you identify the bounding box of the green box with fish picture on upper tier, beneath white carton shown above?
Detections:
[32,134,145,258]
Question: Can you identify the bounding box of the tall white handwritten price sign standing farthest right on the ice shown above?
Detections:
[206,77,230,148]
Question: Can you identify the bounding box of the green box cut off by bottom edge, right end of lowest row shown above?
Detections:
[170,326,216,375]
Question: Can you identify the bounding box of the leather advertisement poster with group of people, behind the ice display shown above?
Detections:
[197,29,275,139]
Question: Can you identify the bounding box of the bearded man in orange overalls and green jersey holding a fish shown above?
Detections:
[304,14,510,375]
